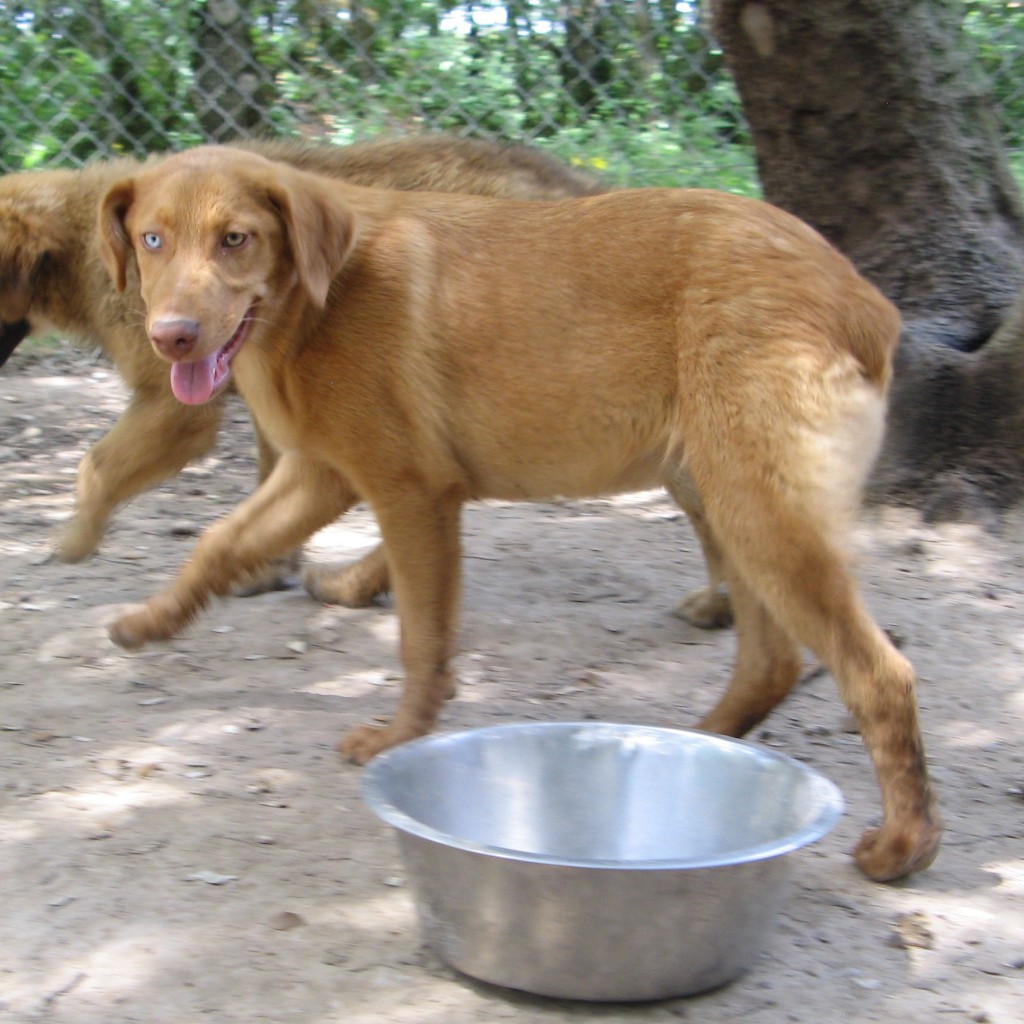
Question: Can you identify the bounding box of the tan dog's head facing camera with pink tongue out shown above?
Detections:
[99,146,355,404]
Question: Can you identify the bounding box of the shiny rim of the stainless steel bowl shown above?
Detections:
[359,721,845,871]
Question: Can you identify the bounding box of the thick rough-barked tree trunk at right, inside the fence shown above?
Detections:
[714,0,1024,516]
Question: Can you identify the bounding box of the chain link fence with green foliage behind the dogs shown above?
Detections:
[0,0,1024,191]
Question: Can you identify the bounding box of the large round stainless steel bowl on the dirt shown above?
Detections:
[362,722,843,1001]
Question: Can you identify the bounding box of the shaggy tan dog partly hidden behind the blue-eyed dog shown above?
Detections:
[0,135,622,602]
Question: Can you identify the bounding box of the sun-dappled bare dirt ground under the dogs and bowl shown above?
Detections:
[0,351,1024,1024]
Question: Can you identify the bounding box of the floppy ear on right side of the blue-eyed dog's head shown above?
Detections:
[269,168,357,308]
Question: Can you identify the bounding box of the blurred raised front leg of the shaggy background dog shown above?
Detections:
[55,388,223,562]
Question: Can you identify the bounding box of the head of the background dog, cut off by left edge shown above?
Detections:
[0,171,69,367]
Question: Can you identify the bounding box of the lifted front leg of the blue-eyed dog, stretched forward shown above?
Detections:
[109,455,356,649]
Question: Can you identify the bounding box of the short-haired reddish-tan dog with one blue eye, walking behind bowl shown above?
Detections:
[99,148,941,880]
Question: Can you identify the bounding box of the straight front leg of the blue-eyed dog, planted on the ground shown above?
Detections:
[340,495,462,764]
